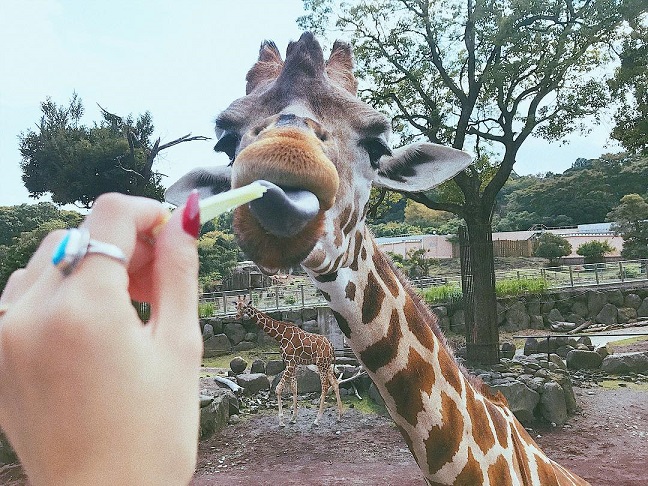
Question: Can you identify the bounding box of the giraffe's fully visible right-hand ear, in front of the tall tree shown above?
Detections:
[373,142,472,192]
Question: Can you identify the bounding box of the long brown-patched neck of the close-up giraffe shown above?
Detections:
[307,229,576,485]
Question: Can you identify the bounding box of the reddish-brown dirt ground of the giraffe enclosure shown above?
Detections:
[0,341,648,486]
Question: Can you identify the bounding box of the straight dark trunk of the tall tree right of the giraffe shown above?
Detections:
[462,217,499,364]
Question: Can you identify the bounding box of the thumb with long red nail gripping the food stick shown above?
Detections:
[152,192,200,341]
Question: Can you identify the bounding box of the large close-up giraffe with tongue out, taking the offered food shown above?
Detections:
[167,33,587,486]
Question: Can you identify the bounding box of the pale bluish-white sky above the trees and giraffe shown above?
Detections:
[0,0,619,206]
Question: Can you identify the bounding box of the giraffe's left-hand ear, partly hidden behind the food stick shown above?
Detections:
[164,165,232,206]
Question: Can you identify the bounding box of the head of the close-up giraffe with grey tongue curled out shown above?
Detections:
[166,33,471,273]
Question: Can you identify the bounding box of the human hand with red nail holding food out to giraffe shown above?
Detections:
[0,194,202,485]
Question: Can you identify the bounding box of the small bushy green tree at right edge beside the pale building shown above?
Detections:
[607,194,648,259]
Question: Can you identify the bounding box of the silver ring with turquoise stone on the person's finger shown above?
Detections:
[52,228,126,275]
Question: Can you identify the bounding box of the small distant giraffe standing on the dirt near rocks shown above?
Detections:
[236,295,342,427]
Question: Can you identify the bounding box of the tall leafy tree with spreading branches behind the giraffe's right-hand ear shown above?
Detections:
[300,0,645,363]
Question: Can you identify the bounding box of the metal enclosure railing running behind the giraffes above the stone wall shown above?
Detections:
[199,259,648,317]
